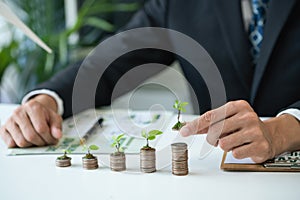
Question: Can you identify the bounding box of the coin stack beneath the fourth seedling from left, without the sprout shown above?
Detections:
[140,148,156,173]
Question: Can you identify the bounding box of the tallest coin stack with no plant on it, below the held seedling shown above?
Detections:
[171,143,189,176]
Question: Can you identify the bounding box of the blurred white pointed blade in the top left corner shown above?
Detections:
[0,0,52,53]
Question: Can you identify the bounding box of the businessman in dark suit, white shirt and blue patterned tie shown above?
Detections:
[0,0,300,162]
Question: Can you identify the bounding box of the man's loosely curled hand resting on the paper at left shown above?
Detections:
[0,94,62,148]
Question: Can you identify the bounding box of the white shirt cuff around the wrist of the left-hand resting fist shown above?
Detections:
[22,89,64,115]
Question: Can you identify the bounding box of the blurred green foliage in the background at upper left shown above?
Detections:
[0,0,144,103]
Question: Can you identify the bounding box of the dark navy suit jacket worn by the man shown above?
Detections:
[35,0,300,117]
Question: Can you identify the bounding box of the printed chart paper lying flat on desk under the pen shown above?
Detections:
[8,109,176,155]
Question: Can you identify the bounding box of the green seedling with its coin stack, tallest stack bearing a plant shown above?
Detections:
[140,130,163,173]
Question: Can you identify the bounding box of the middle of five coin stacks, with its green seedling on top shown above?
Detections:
[110,133,126,171]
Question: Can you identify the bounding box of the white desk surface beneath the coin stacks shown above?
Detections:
[0,104,300,200]
